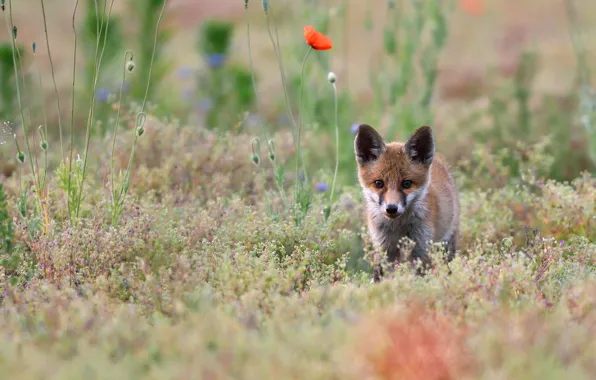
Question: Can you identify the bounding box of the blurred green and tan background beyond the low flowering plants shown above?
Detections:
[0,0,596,189]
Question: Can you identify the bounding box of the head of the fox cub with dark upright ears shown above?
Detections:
[354,124,435,219]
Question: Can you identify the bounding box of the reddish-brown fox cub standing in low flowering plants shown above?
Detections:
[354,124,459,281]
